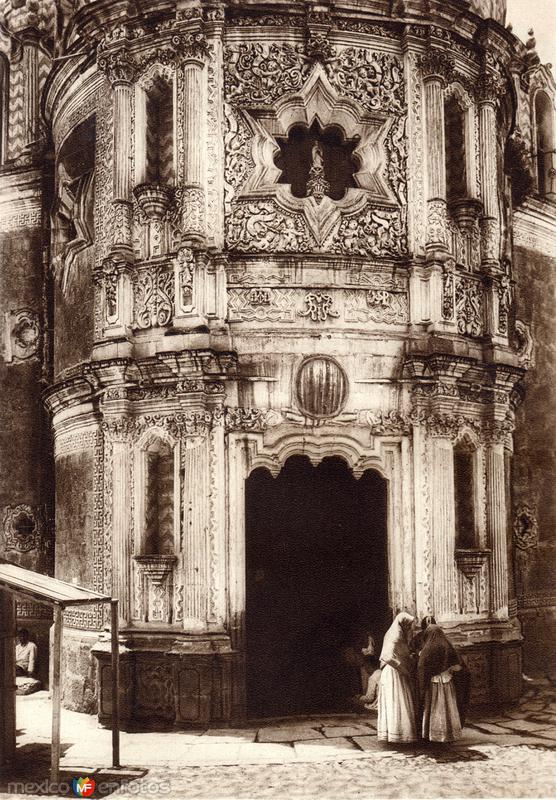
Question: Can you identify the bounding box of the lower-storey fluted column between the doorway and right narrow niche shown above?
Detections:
[431,438,456,619]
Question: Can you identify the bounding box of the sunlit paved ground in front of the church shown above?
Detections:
[0,681,556,800]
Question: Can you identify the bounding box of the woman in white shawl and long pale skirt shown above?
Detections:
[377,611,419,742]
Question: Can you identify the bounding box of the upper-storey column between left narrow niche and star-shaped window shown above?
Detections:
[178,58,206,242]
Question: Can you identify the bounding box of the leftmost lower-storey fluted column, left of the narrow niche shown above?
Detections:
[112,439,131,625]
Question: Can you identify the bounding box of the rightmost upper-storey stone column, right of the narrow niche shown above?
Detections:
[477,73,500,265]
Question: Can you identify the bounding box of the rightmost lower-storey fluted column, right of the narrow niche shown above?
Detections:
[486,443,508,619]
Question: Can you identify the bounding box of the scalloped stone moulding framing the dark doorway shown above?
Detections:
[227,424,412,718]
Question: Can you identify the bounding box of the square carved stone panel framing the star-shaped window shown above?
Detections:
[225,44,407,257]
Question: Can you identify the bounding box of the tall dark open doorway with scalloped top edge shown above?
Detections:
[246,456,391,716]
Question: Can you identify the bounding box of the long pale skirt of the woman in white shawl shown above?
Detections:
[377,664,418,742]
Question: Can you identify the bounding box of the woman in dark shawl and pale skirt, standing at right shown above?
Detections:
[417,625,469,742]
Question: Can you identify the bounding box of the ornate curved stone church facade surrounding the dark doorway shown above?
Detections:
[0,0,556,725]
